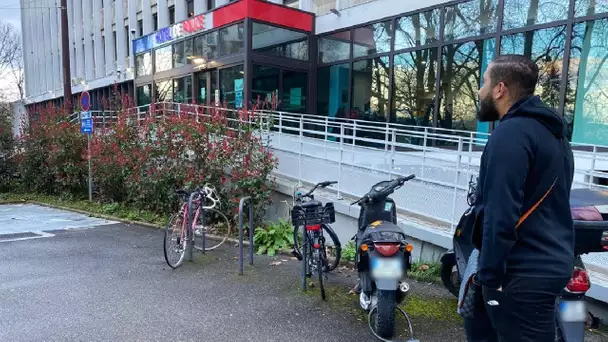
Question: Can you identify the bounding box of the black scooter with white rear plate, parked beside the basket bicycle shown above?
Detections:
[351,175,415,341]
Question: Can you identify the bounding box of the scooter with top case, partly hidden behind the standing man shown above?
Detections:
[441,179,608,342]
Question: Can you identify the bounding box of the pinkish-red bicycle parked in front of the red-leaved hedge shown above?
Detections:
[163,185,230,269]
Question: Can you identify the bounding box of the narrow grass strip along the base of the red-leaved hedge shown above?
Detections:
[0,193,168,226]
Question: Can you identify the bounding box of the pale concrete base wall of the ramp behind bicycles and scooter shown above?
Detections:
[266,179,451,262]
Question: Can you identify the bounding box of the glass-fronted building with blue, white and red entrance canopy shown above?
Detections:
[22,0,608,145]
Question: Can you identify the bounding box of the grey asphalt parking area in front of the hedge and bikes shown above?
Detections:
[0,206,599,341]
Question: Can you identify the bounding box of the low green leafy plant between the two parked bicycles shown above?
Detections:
[253,219,293,256]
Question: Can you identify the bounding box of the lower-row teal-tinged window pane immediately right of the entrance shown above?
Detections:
[317,64,350,118]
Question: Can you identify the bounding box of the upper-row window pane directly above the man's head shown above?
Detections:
[502,0,570,30]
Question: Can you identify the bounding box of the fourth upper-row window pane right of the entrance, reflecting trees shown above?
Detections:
[444,0,498,40]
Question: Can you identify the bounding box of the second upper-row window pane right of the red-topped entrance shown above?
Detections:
[353,21,393,57]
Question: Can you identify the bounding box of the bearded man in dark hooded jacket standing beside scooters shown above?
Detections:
[476,55,574,342]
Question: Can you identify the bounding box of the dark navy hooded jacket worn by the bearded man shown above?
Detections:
[476,96,574,289]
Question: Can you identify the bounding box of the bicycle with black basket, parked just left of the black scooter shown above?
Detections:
[291,182,341,300]
